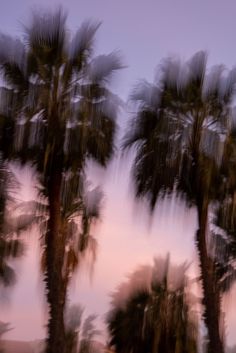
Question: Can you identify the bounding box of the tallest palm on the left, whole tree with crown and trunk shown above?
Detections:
[0,9,122,353]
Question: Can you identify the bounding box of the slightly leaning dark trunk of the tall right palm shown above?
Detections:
[196,199,224,353]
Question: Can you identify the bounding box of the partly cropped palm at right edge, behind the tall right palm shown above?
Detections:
[212,121,236,293]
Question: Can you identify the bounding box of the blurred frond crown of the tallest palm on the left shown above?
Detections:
[0,10,122,178]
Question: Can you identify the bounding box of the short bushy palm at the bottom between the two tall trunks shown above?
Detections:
[107,257,197,353]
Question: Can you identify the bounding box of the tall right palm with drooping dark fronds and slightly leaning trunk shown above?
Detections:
[125,52,235,353]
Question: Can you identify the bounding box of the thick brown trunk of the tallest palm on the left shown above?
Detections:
[45,171,66,353]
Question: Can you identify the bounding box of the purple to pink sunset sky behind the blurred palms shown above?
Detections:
[0,0,236,344]
